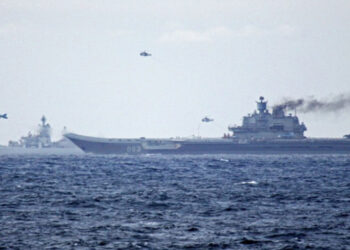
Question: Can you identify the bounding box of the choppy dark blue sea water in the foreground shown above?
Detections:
[0,155,350,249]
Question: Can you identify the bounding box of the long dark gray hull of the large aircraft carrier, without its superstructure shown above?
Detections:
[65,133,350,154]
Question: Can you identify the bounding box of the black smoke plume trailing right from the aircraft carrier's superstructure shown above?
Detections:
[273,94,350,113]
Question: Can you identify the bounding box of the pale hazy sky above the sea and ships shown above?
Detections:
[0,0,350,144]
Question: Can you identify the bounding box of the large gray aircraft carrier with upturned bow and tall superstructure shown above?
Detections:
[64,97,350,154]
